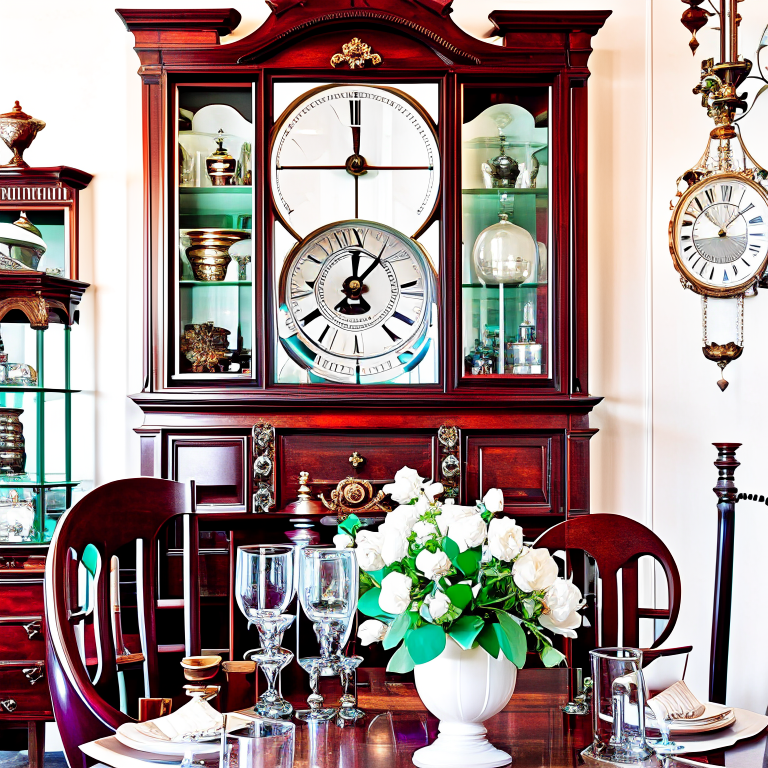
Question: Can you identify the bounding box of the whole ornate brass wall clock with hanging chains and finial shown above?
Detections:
[669,0,768,390]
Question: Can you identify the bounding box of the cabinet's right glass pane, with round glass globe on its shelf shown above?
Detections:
[461,85,552,380]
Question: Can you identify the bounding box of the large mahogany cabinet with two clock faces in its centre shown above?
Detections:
[118,0,610,696]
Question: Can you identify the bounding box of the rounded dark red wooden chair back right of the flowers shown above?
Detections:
[533,514,680,648]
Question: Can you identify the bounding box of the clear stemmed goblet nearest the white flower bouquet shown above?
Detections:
[296,547,358,720]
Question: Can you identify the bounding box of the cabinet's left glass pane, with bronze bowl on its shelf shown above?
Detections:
[175,84,254,379]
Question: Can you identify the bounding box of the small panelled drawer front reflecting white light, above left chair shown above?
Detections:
[169,435,250,512]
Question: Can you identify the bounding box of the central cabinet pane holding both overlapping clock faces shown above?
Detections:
[269,82,441,385]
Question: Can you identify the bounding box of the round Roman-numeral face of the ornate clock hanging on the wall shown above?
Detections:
[670,173,768,296]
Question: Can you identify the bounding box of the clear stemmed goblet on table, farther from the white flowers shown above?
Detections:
[235,545,296,717]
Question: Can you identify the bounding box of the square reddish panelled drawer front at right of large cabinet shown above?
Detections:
[466,434,563,515]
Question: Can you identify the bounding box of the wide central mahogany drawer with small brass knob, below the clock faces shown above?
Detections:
[278,430,438,508]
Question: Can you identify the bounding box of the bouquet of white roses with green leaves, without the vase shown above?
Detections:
[334,467,584,673]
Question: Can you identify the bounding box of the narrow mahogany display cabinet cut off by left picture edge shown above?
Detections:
[0,166,92,768]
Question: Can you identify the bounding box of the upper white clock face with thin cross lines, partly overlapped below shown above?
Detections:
[270,85,440,239]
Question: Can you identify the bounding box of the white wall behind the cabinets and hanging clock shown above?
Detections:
[0,0,768,711]
